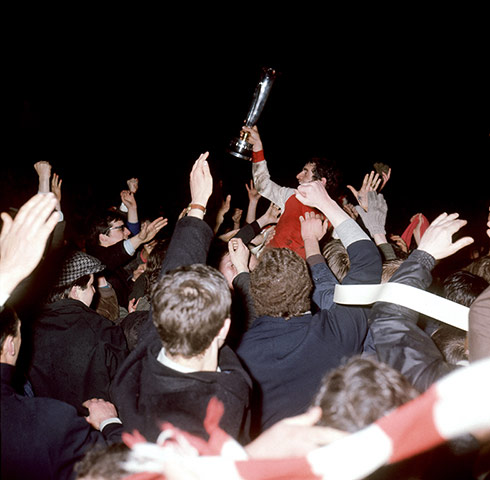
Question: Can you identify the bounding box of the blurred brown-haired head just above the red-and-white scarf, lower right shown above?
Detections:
[314,356,419,433]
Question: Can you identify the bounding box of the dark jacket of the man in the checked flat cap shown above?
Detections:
[28,299,128,413]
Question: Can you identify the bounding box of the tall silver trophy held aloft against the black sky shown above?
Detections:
[228,67,277,160]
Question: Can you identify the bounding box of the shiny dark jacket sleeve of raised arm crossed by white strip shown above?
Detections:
[370,250,460,392]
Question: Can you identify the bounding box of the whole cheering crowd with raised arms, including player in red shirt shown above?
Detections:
[0,126,490,480]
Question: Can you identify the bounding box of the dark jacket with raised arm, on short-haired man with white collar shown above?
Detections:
[111,217,251,442]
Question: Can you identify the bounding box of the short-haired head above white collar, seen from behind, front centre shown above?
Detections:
[151,264,231,358]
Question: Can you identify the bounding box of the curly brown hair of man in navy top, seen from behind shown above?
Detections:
[250,248,313,318]
